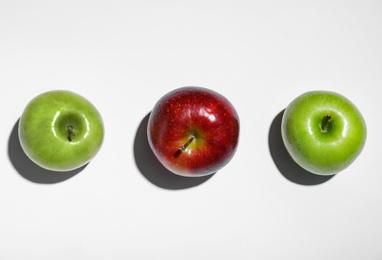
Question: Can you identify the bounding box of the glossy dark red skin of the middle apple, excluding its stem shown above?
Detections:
[147,87,239,177]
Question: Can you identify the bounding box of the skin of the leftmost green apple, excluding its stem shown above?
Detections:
[19,90,104,171]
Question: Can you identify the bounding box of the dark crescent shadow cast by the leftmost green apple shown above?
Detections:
[8,119,87,184]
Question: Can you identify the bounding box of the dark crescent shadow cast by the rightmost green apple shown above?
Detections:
[268,109,334,185]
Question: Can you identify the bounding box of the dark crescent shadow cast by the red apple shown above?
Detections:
[134,113,214,190]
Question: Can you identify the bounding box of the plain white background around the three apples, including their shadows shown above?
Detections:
[0,0,382,260]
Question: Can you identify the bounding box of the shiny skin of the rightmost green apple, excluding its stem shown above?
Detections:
[281,91,367,175]
